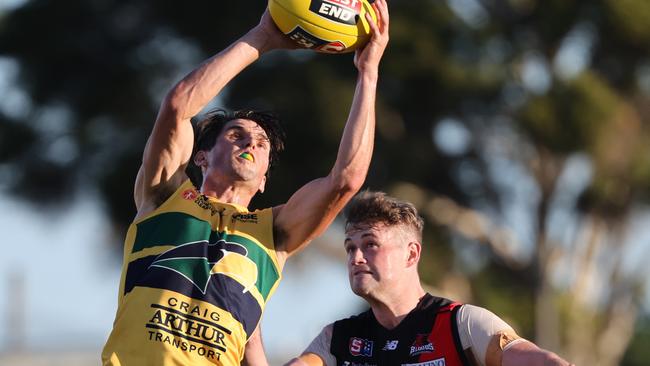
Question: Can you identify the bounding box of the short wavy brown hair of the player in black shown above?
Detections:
[344,191,424,240]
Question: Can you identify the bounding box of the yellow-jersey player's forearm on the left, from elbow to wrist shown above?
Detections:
[163,30,267,120]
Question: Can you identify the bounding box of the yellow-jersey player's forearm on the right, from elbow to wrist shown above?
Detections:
[332,71,377,191]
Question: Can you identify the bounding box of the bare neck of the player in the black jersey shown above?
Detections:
[366,281,425,329]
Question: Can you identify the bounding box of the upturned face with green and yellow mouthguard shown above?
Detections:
[201,119,271,184]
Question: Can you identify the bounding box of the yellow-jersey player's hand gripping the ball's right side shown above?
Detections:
[354,0,389,72]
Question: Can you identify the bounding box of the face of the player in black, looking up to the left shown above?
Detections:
[344,224,408,298]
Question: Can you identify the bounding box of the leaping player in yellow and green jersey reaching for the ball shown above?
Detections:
[102,0,388,365]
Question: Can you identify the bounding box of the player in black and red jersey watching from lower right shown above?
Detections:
[287,192,570,366]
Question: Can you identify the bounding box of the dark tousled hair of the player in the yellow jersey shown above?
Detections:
[187,108,286,187]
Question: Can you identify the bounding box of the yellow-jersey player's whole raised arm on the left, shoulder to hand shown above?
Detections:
[134,11,294,215]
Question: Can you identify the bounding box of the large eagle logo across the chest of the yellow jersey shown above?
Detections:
[149,239,257,295]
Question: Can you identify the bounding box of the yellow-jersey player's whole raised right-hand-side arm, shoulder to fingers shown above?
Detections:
[274,0,389,262]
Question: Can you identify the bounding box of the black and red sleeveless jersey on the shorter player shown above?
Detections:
[330,294,471,366]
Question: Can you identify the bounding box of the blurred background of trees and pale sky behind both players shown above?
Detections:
[0,0,650,366]
